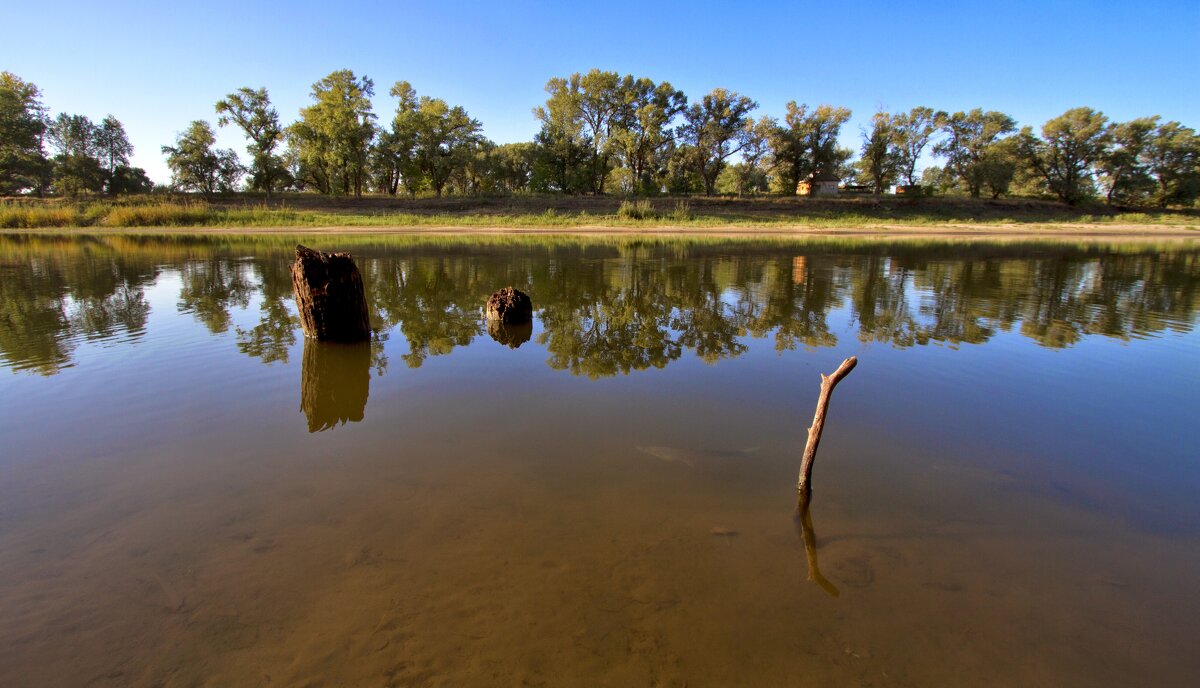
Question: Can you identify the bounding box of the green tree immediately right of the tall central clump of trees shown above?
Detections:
[683,89,758,196]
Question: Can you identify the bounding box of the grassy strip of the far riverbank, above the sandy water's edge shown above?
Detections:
[0,193,1200,231]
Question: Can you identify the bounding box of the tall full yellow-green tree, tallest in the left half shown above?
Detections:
[288,70,376,196]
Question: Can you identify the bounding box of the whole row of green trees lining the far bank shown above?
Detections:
[0,70,1200,207]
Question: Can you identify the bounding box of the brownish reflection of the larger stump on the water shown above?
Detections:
[300,337,371,432]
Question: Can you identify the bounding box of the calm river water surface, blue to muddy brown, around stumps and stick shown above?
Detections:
[0,235,1200,687]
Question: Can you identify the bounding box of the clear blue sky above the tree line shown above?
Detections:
[0,0,1200,181]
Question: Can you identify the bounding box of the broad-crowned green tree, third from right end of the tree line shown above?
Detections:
[1018,108,1109,205]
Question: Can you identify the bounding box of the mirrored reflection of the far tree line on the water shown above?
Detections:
[0,241,1200,377]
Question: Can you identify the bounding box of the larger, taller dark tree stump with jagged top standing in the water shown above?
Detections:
[292,246,371,341]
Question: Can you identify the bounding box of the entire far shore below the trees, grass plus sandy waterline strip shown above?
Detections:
[0,193,1200,240]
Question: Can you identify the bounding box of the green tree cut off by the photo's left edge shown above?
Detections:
[0,72,47,195]
